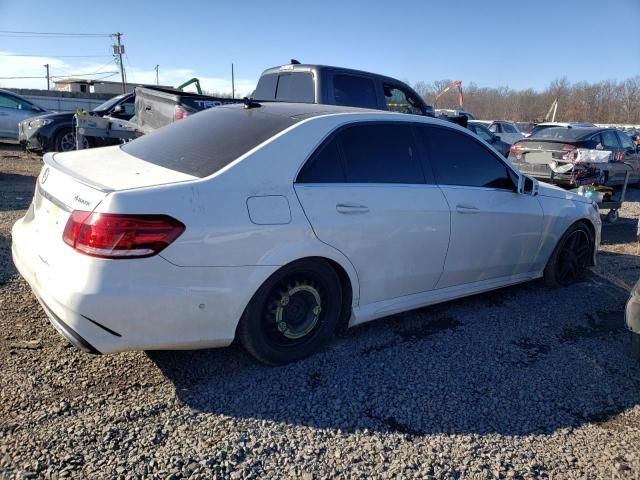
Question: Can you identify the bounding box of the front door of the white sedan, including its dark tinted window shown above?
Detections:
[421,126,543,288]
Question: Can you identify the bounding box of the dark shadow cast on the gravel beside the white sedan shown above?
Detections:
[148,254,640,438]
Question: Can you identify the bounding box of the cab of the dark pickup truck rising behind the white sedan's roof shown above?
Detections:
[253,61,434,116]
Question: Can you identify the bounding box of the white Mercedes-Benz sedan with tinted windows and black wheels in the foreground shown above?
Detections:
[13,103,601,364]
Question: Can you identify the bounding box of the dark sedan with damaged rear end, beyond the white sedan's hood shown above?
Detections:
[509,127,640,186]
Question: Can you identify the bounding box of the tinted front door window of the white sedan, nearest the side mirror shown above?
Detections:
[420,127,515,190]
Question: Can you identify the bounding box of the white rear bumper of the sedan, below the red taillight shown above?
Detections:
[12,220,277,353]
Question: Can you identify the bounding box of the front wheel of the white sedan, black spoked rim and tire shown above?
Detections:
[544,222,594,287]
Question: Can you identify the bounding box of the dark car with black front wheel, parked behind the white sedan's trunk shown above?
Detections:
[18,93,135,152]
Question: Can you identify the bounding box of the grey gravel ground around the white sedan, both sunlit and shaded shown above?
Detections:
[0,145,640,480]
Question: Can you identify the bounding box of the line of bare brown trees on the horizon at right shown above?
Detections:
[414,75,640,125]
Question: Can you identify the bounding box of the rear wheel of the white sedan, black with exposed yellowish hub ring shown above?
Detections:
[238,259,342,365]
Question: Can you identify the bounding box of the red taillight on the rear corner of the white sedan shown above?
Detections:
[62,210,185,258]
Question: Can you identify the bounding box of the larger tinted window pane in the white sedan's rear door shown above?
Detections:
[339,124,424,183]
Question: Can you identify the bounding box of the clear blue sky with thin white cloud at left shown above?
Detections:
[0,0,640,94]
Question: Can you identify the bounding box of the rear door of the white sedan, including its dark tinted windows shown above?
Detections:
[295,122,450,305]
